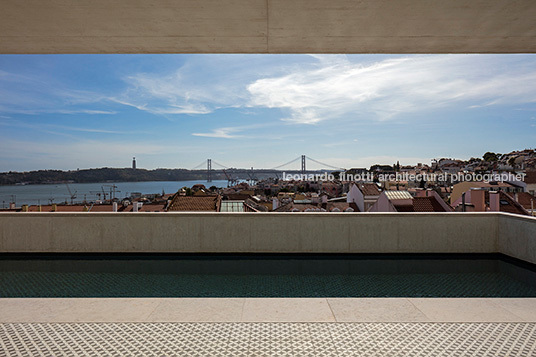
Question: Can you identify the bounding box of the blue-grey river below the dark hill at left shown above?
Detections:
[0,180,227,208]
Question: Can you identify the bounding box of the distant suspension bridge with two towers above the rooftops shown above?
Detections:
[190,155,345,184]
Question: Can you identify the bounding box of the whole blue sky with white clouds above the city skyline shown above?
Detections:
[0,55,536,171]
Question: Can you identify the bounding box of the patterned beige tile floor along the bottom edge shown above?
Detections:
[0,322,536,357]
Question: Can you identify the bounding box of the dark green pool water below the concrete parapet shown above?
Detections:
[0,255,536,297]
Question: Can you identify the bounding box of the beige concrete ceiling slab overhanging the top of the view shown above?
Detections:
[0,0,536,54]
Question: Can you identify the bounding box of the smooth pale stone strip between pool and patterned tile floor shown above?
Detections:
[0,298,536,323]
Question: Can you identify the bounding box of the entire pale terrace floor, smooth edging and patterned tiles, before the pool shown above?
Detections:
[0,298,536,356]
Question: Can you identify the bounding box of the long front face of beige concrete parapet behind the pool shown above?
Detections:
[0,213,500,253]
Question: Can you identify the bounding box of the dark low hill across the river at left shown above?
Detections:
[0,167,220,185]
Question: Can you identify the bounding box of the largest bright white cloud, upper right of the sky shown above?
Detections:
[248,55,536,124]
